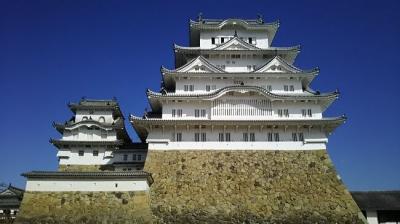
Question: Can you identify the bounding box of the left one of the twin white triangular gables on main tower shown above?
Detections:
[175,56,224,73]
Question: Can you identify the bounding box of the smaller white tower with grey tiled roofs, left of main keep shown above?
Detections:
[50,99,147,171]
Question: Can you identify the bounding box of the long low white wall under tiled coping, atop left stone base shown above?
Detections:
[25,178,149,192]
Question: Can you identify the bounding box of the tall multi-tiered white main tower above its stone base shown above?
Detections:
[130,18,345,150]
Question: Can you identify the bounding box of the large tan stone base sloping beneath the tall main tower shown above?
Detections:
[145,150,365,224]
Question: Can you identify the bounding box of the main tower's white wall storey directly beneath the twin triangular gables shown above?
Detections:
[175,74,303,94]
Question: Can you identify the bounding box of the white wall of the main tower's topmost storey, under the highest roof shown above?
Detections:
[200,27,269,49]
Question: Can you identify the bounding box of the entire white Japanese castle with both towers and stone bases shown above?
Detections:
[16,15,365,223]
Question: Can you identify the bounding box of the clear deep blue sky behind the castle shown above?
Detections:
[0,0,400,190]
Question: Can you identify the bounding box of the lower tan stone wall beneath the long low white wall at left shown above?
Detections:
[15,192,151,224]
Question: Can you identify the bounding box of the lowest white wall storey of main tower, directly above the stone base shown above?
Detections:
[146,126,328,150]
